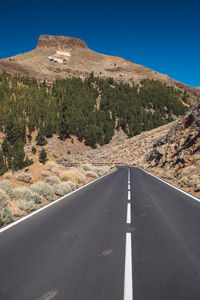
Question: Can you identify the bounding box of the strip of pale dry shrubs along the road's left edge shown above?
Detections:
[0,161,113,226]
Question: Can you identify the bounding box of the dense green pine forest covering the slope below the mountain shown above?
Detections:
[0,73,190,175]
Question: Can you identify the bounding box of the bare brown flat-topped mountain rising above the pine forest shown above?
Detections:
[0,35,200,102]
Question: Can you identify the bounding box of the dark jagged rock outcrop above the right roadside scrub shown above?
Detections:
[147,104,200,168]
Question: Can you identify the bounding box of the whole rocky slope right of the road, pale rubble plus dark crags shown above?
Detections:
[68,104,200,197]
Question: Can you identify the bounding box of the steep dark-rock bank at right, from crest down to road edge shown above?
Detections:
[146,104,200,195]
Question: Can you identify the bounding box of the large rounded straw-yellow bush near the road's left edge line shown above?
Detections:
[60,168,86,184]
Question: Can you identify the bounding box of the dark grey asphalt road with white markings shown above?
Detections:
[0,167,200,300]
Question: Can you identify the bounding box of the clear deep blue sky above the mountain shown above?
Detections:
[0,0,200,86]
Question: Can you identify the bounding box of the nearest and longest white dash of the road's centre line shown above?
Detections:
[124,232,133,300]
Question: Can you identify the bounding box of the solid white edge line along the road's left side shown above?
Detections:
[0,170,117,233]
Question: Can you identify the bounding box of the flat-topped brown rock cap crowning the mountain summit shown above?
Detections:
[37,35,88,50]
